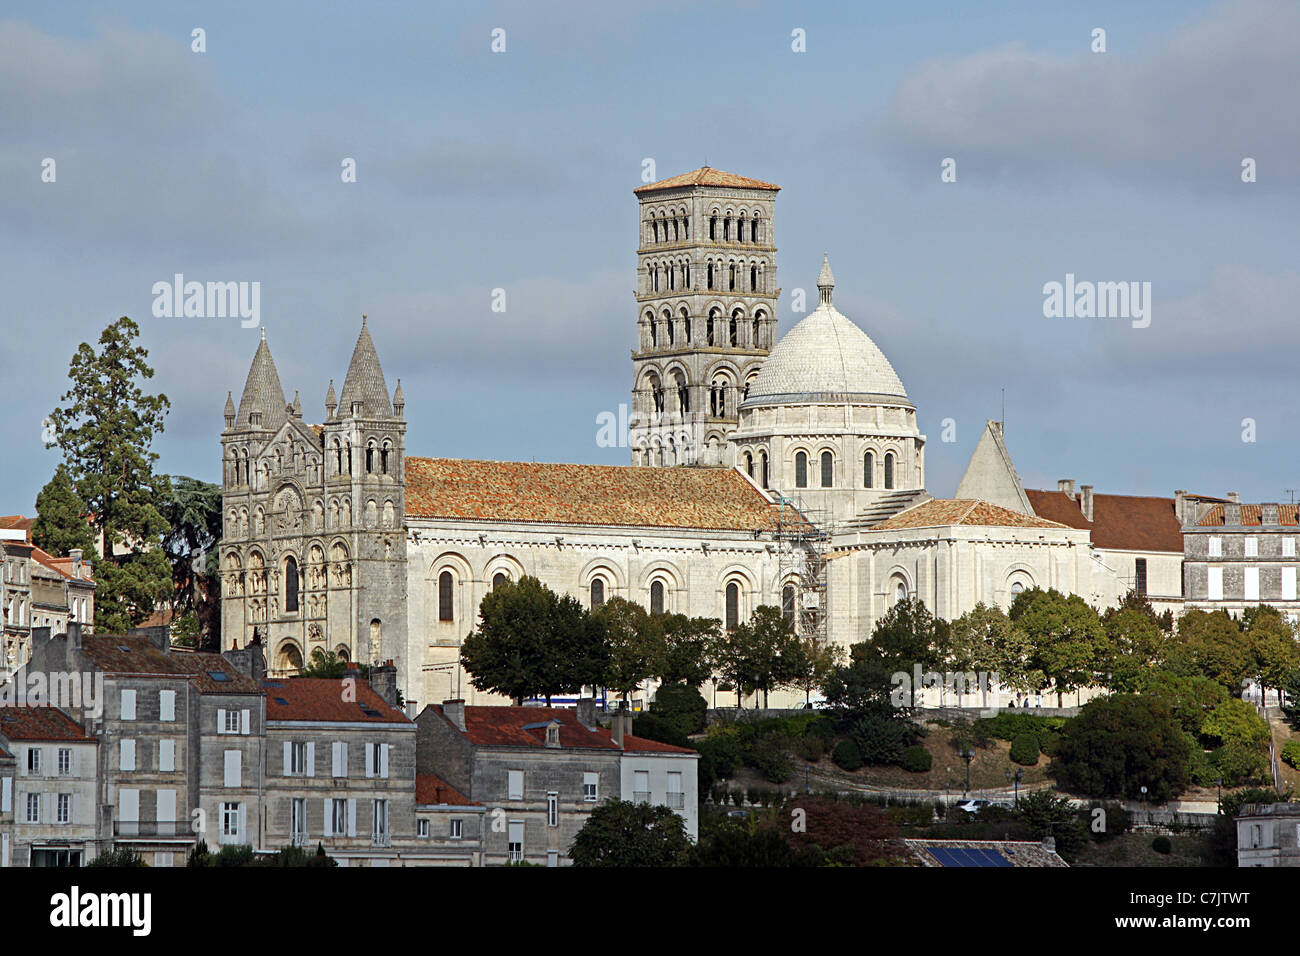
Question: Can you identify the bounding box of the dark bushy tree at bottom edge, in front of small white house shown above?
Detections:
[568,800,690,866]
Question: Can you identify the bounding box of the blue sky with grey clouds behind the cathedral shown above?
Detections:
[0,0,1300,514]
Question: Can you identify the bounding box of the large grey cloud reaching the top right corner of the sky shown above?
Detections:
[878,0,1300,189]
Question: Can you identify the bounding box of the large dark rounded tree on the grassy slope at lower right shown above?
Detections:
[1052,693,1191,803]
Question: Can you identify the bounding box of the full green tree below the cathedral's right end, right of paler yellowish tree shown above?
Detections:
[1013,588,1112,706]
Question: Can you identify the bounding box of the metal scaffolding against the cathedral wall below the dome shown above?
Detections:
[774,496,835,643]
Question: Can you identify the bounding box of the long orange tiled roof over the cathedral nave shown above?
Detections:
[406,458,789,531]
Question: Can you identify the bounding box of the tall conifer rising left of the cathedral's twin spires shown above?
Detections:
[49,316,172,632]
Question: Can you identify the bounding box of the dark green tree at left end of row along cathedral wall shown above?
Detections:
[460,576,608,704]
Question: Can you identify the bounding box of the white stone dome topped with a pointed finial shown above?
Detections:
[741,261,907,407]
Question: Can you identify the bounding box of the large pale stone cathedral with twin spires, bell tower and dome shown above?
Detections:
[221,166,1182,704]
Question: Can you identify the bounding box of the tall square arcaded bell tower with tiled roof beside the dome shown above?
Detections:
[628,166,781,466]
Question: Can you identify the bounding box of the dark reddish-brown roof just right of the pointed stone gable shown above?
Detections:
[1024,488,1183,553]
